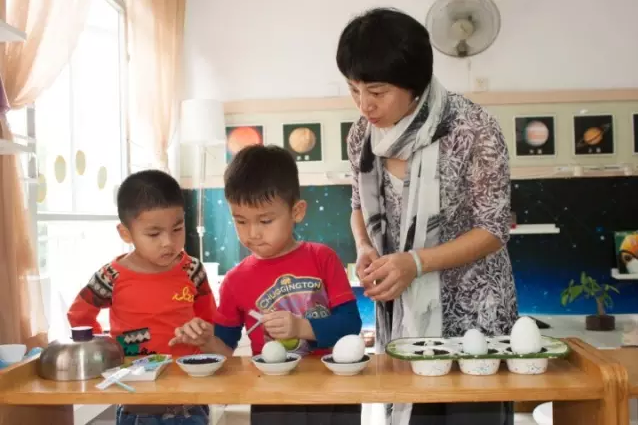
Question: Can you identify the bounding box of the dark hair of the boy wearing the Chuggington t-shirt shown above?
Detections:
[224,145,301,207]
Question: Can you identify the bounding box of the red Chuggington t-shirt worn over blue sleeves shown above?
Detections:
[214,242,355,355]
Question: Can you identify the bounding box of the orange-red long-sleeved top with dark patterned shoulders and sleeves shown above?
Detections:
[67,253,216,356]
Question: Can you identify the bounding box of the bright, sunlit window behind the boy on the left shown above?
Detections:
[9,0,127,338]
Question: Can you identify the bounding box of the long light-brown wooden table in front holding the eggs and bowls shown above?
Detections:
[0,339,628,424]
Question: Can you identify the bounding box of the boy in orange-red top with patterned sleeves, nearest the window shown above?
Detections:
[67,170,215,424]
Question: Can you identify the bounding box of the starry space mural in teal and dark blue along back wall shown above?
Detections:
[185,177,638,320]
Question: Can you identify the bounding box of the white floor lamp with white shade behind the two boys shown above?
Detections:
[180,99,226,262]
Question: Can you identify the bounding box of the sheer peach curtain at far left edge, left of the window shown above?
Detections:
[0,0,89,345]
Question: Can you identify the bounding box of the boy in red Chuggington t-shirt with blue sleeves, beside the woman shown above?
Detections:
[173,146,361,425]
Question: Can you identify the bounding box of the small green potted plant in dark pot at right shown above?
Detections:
[561,272,620,331]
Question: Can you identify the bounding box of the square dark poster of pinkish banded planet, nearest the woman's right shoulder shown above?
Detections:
[514,116,556,157]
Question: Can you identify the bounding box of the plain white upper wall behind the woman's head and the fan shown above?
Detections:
[184,0,638,100]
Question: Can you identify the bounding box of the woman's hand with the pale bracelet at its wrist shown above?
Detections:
[361,253,416,302]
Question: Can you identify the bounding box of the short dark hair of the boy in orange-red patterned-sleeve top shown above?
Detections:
[117,170,184,226]
